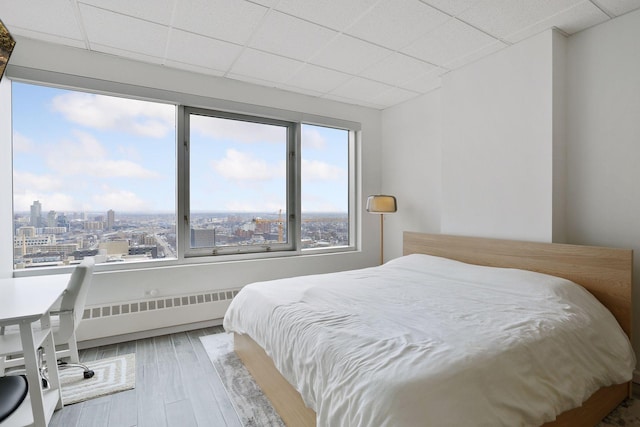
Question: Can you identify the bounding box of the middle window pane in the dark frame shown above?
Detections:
[185,109,295,255]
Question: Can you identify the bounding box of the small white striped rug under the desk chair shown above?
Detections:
[59,354,136,405]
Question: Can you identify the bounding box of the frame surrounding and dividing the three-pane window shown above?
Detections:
[3,65,362,277]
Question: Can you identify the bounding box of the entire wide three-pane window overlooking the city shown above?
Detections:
[11,76,359,269]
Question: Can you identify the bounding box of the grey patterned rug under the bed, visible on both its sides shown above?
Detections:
[200,333,640,427]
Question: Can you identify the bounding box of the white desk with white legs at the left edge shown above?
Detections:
[0,274,71,427]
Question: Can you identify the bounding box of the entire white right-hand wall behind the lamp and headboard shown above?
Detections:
[382,11,640,372]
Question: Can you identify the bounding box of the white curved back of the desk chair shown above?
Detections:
[59,258,95,341]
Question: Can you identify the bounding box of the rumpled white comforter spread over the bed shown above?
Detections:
[224,255,635,427]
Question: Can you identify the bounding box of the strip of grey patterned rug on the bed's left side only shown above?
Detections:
[200,333,285,427]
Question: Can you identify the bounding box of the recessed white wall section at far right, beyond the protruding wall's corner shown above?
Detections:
[567,11,640,355]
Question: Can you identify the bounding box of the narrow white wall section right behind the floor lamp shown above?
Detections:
[381,90,442,261]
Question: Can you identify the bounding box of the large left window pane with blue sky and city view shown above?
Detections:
[12,82,176,268]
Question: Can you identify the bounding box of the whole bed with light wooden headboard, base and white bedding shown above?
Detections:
[224,232,635,426]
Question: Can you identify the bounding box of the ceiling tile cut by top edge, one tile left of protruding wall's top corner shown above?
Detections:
[459,0,583,39]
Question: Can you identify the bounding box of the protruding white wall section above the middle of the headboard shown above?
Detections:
[442,31,557,241]
